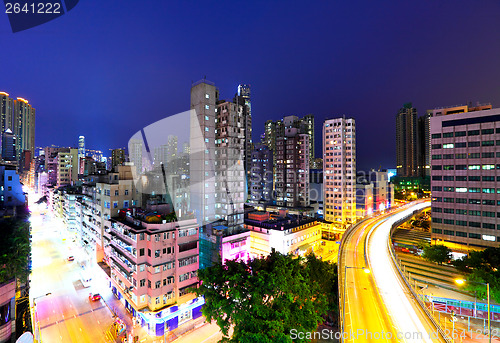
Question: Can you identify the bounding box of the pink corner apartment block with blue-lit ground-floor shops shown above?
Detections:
[105,209,204,337]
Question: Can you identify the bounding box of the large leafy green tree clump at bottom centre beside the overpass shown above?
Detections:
[195,250,337,343]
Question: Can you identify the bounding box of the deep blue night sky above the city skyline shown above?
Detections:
[0,0,500,169]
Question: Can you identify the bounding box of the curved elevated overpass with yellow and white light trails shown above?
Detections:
[339,202,447,343]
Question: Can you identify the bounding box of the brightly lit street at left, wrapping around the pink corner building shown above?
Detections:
[26,195,226,343]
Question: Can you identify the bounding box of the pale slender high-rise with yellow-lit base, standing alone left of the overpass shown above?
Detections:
[323,118,356,225]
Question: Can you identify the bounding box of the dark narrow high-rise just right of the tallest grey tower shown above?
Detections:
[250,144,273,202]
